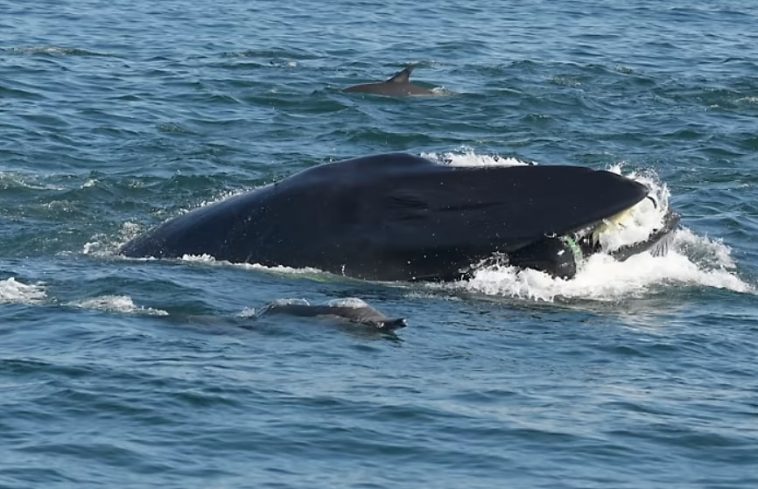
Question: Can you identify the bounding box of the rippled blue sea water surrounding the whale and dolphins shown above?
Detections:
[0,0,758,489]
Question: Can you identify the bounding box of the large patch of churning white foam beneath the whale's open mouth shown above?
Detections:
[452,230,755,302]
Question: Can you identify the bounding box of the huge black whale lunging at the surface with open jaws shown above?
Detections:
[121,154,677,281]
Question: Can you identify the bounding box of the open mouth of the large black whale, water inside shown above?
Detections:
[508,196,679,278]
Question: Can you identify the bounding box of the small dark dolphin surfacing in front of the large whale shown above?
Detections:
[255,297,406,332]
